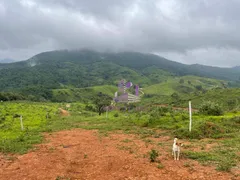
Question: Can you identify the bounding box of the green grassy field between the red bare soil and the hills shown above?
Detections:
[0,102,240,171]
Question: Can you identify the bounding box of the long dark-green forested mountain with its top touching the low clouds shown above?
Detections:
[0,50,240,91]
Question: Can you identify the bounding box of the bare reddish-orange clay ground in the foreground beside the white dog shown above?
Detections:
[0,129,239,180]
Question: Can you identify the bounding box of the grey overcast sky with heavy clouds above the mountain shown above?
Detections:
[0,0,240,67]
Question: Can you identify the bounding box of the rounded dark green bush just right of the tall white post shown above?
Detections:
[199,101,223,116]
